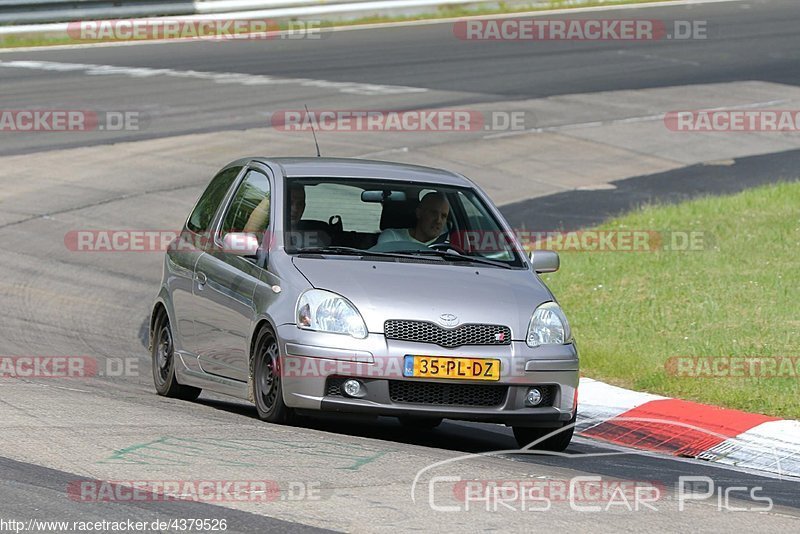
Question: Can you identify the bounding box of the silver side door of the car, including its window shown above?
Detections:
[192,168,272,382]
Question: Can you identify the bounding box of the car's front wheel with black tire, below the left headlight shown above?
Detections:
[253,328,294,424]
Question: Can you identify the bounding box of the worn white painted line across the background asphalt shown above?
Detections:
[0,61,428,96]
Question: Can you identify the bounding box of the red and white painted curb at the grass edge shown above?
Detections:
[576,377,800,477]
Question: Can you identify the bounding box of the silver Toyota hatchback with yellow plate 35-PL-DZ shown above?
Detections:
[150,158,578,450]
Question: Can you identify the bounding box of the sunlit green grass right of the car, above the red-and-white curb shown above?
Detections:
[545,182,800,419]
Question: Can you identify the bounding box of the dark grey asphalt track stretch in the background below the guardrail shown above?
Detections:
[0,0,800,154]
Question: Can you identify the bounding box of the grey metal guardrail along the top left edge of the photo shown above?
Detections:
[0,0,380,25]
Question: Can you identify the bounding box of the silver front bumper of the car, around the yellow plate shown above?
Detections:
[278,325,579,427]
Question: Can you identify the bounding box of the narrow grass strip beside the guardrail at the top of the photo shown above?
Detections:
[0,0,667,48]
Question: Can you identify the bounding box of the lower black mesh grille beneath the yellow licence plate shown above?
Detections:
[389,380,508,406]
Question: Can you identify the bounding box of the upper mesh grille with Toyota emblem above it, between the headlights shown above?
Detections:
[383,319,511,349]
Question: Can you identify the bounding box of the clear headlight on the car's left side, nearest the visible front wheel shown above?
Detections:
[295,289,367,339]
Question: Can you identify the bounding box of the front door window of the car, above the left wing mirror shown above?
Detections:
[222,171,270,242]
